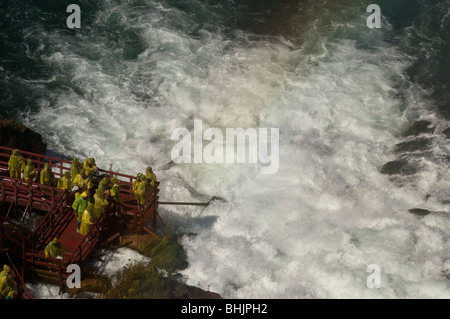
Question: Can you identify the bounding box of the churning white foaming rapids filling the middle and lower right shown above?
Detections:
[22,0,450,298]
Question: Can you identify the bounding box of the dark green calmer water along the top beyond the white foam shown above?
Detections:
[0,0,450,118]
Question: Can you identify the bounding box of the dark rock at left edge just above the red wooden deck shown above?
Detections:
[0,119,47,154]
